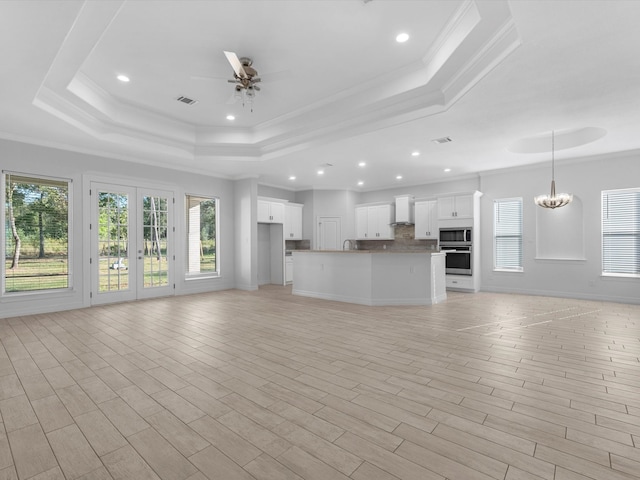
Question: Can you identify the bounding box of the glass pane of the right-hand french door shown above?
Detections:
[142,196,169,288]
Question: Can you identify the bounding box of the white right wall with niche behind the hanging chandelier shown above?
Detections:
[480,154,640,303]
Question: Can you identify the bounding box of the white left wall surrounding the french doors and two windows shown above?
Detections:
[0,140,236,318]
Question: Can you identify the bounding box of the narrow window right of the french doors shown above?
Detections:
[186,195,219,277]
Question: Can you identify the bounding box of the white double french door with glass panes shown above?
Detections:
[90,182,175,304]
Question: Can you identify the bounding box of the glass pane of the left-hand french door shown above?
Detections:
[98,192,129,292]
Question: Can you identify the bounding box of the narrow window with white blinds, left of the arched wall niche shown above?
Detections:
[493,198,522,272]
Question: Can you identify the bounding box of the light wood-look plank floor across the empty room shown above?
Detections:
[0,286,640,480]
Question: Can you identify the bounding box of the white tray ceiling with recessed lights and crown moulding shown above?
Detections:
[0,0,640,190]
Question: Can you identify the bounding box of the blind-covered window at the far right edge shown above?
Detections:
[602,188,640,277]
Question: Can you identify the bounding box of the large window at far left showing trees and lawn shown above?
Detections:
[2,173,71,293]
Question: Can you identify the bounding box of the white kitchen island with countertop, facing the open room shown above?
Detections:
[292,250,447,306]
